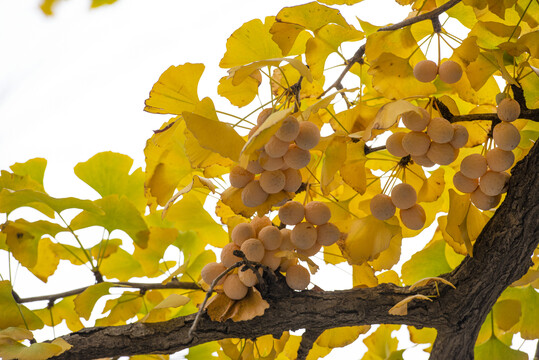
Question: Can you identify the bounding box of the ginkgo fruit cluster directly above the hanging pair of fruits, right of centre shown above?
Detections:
[386,107,468,167]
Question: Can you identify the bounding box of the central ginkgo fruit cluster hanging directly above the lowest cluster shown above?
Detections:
[230,109,320,207]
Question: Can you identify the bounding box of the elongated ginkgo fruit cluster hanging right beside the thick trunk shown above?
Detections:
[453,98,520,210]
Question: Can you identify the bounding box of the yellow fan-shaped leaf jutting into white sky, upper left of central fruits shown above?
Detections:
[144,63,204,115]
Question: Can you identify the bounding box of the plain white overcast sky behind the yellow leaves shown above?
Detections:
[0,0,534,360]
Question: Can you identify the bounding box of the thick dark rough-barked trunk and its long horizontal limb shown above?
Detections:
[49,144,539,360]
